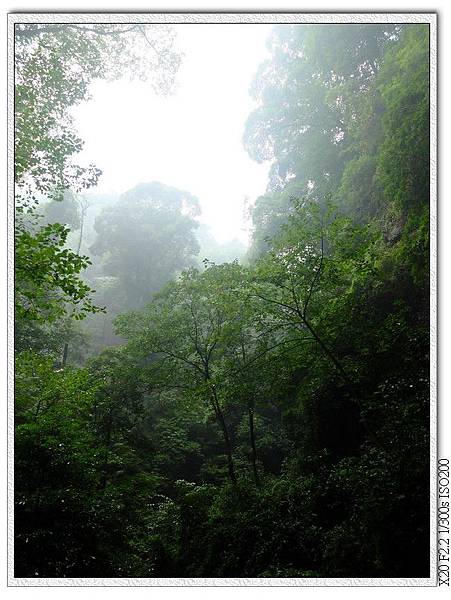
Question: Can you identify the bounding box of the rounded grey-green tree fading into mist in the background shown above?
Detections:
[91,182,199,309]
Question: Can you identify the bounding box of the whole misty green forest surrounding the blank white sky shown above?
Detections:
[15,24,429,577]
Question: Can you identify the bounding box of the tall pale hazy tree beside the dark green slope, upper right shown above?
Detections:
[244,24,400,252]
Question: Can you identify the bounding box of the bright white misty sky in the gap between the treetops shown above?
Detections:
[73,24,271,242]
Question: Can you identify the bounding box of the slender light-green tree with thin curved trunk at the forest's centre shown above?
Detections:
[117,263,254,483]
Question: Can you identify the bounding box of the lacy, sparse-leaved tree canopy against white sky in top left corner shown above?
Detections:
[15,24,180,205]
